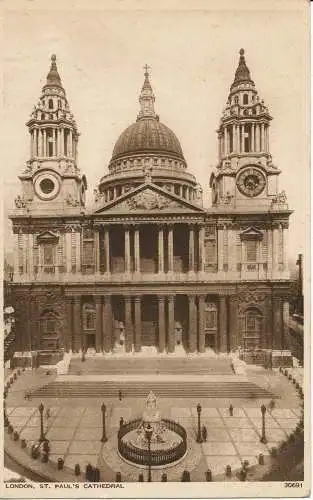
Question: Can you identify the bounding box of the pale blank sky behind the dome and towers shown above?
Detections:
[2,0,309,259]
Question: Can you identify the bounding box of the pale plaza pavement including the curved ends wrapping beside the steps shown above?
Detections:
[7,369,301,481]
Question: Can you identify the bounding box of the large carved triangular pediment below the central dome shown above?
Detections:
[96,183,203,214]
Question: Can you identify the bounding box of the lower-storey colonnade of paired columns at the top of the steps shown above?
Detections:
[63,294,230,353]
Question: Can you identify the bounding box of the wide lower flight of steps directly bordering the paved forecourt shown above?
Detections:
[32,376,276,399]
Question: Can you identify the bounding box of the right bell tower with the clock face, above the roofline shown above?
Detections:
[210,49,280,210]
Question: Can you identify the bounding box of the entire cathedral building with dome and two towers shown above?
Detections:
[10,49,292,362]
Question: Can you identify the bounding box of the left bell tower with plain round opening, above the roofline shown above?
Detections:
[15,55,87,213]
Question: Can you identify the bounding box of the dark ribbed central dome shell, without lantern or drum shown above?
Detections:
[112,117,185,161]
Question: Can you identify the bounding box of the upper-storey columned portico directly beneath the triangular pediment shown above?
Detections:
[94,221,205,275]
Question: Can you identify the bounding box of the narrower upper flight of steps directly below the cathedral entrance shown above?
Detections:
[69,356,234,375]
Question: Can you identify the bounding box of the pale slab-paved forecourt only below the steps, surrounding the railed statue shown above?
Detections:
[8,402,300,480]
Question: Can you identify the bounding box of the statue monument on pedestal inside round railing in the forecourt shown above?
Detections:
[118,392,187,467]
